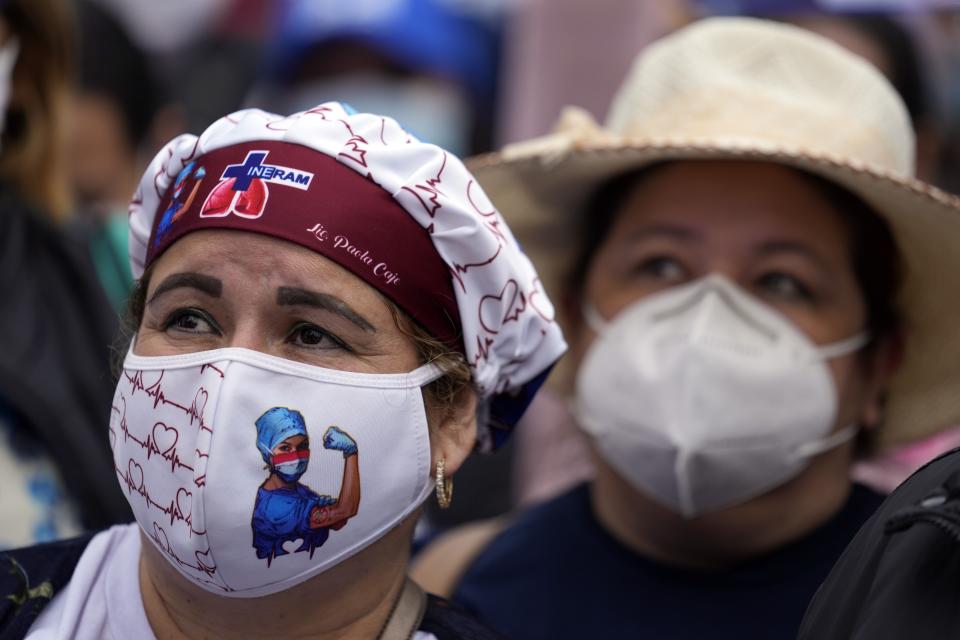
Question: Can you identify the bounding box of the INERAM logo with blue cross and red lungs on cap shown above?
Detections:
[200,151,313,219]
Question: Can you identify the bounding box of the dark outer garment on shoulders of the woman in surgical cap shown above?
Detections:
[0,535,502,640]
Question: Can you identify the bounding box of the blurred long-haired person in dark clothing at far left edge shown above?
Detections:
[0,0,130,547]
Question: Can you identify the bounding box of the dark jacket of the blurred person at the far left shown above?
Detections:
[0,185,132,528]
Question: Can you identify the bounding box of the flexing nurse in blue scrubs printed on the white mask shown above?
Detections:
[252,407,360,566]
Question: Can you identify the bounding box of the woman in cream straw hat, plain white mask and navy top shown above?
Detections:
[415,19,960,640]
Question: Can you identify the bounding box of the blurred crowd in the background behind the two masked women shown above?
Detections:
[0,0,960,547]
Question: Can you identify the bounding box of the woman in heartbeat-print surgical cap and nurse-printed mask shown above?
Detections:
[0,103,565,640]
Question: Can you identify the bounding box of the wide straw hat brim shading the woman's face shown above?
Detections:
[468,141,960,448]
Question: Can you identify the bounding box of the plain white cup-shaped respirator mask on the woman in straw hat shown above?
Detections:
[574,275,868,517]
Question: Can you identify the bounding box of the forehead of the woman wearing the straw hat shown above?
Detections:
[612,161,847,246]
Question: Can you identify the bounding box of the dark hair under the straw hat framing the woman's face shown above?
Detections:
[567,163,902,338]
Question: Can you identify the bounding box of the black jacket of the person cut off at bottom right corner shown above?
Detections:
[800,449,960,640]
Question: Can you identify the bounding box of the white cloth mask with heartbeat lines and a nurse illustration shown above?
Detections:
[110,348,442,597]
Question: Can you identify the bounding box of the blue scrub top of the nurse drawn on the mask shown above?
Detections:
[253,482,336,562]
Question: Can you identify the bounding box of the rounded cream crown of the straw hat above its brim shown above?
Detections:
[607,18,914,177]
